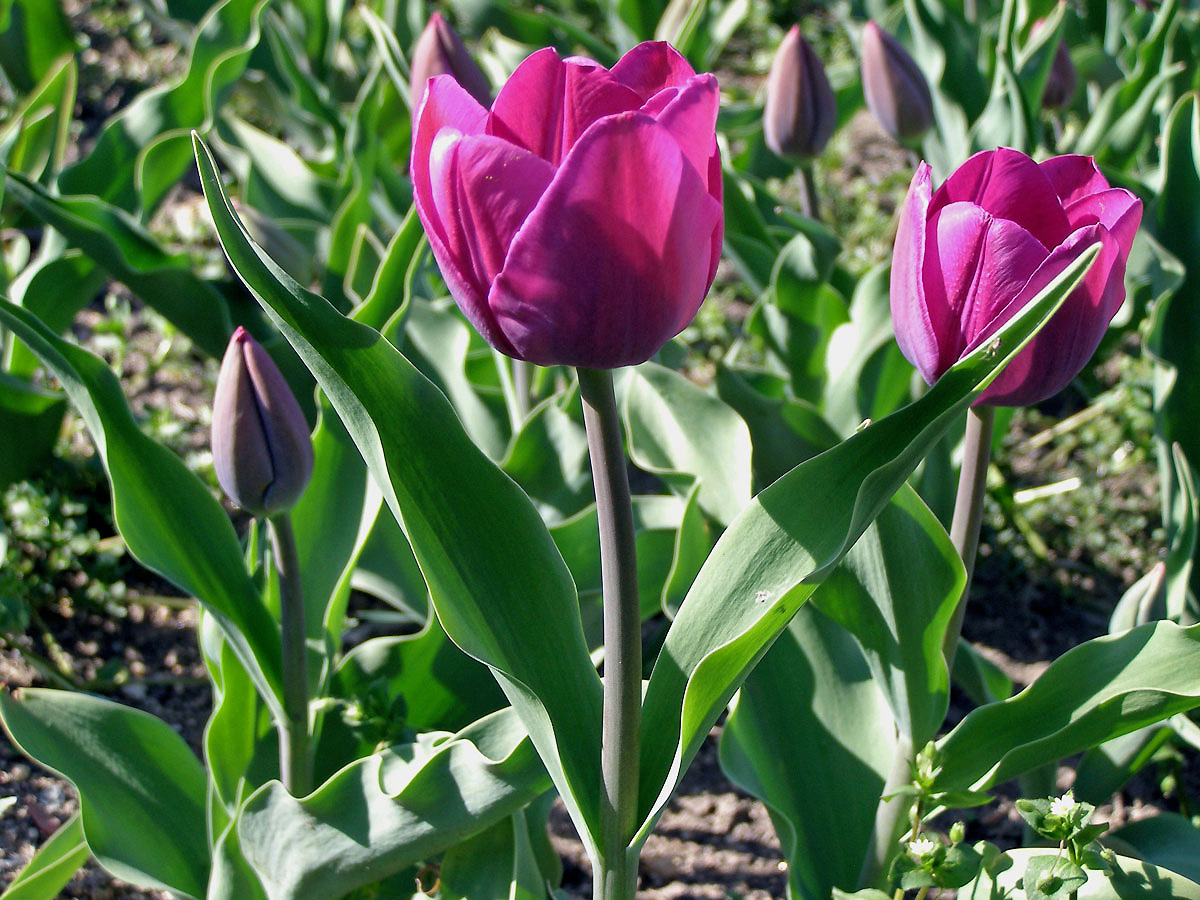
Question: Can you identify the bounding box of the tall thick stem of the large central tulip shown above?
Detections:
[578,368,642,900]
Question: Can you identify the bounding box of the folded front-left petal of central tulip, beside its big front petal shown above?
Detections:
[430,128,554,349]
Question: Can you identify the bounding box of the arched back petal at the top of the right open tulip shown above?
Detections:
[930,146,1072,247]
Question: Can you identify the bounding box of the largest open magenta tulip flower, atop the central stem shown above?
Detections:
[412,43,724,368]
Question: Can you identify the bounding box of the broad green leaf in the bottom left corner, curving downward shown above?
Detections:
[0,688,209,900]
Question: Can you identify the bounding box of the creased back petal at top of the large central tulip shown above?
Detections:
[487,47,642,166]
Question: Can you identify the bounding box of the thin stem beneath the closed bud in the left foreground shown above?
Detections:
[268,512,312,797]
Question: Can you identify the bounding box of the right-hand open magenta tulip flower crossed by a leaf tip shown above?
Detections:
[892,148,1141,406]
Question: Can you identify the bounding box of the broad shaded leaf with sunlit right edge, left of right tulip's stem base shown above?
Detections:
[720,606,895,900]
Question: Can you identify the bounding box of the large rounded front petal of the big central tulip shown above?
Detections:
[488,113,721,368]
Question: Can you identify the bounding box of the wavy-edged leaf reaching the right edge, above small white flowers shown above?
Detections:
[934,622,1200,791]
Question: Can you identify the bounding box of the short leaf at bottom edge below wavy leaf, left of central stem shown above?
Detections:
[438,811,546,900]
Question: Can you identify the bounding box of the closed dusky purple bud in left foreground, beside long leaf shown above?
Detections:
[212,328,313,517]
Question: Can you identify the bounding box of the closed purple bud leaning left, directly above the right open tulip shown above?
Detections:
[860,22,934,143]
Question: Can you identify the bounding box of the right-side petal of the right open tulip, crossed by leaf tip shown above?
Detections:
[976,224,1124,406]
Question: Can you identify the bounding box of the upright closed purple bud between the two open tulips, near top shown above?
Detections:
[762,25,838,160]
